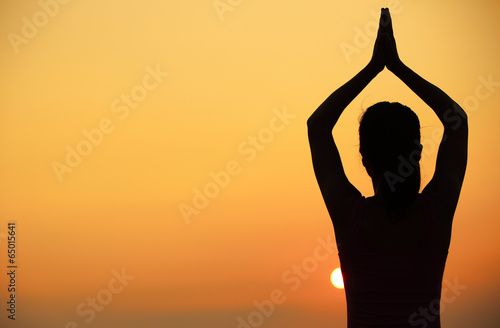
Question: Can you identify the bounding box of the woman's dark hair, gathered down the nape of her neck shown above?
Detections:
[359,102,422,222]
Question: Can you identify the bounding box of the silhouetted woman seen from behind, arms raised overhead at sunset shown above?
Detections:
[307,9,468,328]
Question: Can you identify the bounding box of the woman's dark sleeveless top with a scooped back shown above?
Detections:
[338,194,449,328]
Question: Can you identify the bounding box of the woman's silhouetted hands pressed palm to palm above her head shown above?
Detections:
[369,8,402,73]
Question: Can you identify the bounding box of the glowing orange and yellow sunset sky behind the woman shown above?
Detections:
[0,0,500,328]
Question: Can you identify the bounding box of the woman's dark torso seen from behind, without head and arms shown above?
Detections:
[339,195,449,328]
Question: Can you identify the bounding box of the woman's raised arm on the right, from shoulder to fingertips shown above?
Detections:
[385,8,468,225]
